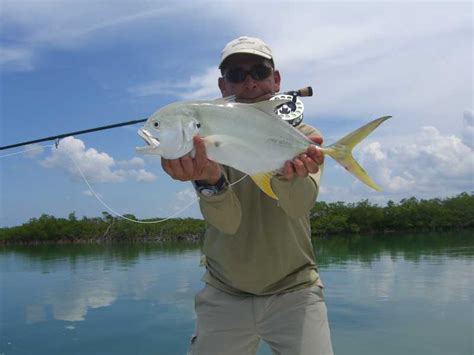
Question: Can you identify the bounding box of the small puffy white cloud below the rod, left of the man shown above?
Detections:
[41,137,156,183]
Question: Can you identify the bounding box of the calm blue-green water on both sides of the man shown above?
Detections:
[0,233,474,355]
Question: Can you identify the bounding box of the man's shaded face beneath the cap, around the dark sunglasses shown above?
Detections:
[219,54,280,103]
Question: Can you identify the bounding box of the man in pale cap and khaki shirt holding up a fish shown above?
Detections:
[162,37,332,355]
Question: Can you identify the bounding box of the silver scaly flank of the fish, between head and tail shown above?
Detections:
[192,101,311,175]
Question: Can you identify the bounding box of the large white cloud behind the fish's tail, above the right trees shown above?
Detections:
[318,117,474,204]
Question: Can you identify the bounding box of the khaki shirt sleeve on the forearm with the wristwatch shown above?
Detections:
[198,168,242,234]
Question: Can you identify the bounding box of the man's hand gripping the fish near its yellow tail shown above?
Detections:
[283,135,324,180]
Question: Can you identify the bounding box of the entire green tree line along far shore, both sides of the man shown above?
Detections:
[0,193,474,243]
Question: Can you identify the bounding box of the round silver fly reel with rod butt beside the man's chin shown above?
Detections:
[270,86,313,127]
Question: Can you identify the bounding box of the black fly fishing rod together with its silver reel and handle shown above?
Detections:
[0,86,313,150]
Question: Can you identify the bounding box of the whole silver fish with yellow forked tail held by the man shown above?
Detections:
[137,98,391,199]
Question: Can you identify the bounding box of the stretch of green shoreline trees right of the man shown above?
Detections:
[311,192,474,236]
